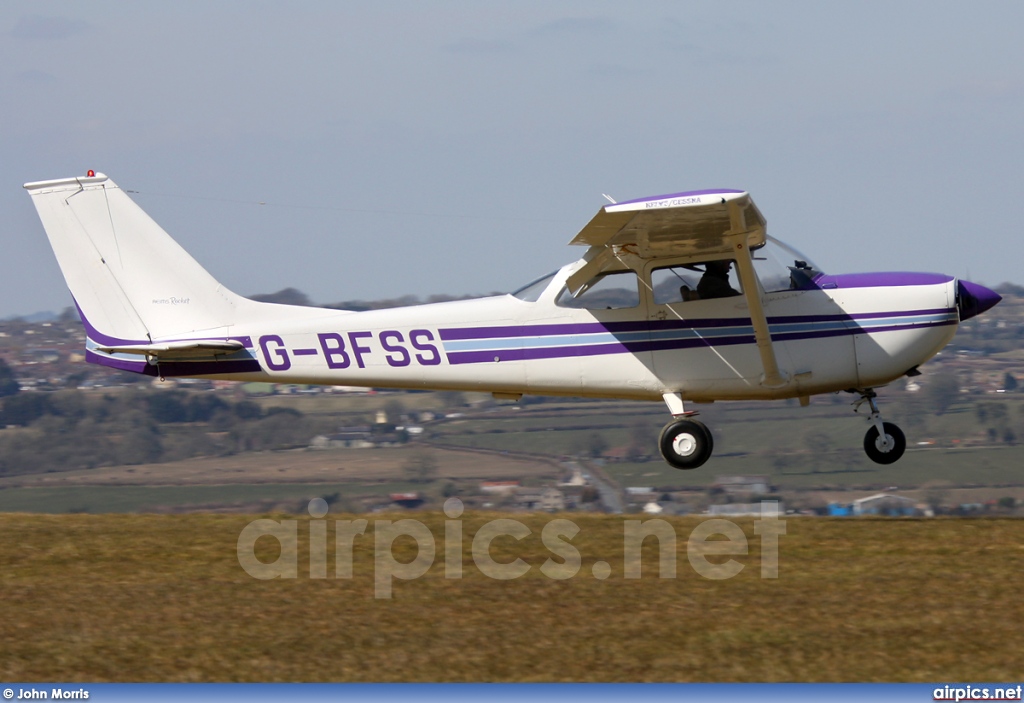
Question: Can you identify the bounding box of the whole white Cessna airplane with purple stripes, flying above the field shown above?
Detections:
[25,171,1000,469]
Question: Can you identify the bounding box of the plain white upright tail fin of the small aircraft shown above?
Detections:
[25,172,247,344]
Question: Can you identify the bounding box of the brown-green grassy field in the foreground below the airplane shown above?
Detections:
[0,514,1024,682]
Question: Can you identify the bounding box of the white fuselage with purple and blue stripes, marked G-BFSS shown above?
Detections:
[89,266,959,401]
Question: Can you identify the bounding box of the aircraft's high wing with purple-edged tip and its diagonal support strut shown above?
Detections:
[566,189,786,387]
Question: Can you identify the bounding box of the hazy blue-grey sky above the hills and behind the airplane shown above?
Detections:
[0,0,1024,317]
